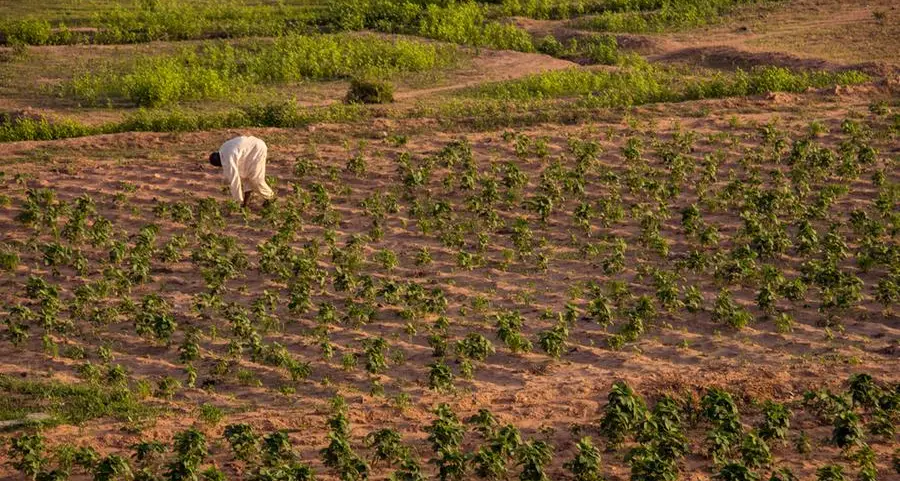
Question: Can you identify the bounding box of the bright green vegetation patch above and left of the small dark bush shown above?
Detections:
[63,34,458,106]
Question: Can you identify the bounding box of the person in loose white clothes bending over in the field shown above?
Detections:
[209,135,275,207]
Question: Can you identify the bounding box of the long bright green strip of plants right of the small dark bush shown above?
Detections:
[420,65,869,130]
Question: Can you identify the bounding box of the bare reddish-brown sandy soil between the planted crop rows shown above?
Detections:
[0,85,900,480]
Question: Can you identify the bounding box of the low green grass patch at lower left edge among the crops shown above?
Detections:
[0,375,156,424]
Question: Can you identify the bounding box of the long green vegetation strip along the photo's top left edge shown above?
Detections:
[0,0,533,51]
